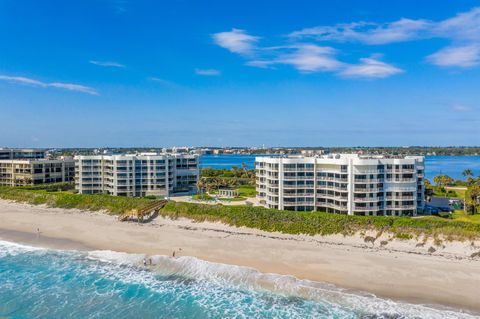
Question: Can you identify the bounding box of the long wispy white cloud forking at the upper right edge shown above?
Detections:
[289,7,480,68]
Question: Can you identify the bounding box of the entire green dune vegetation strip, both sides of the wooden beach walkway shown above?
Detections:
[0,185,480,240]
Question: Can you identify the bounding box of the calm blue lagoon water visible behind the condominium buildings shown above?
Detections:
[200,155,480,180]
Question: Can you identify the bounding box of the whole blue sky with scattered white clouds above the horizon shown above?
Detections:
[0,0,480,147]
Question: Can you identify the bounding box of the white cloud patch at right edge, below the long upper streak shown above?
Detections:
[427,44,480,68]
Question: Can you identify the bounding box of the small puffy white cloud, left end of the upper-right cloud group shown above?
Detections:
[212,28,259,54]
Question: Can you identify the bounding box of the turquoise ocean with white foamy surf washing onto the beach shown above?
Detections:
[0,241,474,319]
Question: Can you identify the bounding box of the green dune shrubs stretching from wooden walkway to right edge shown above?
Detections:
[160,202,480,240]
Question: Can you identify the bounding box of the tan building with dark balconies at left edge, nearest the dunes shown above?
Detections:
[0,159,75,186]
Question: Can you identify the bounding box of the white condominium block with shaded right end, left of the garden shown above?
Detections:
[75,153,199,197]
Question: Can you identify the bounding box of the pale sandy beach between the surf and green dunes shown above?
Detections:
[0,200,480,312]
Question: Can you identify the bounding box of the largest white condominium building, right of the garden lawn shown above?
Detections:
[255,154,425,216]
